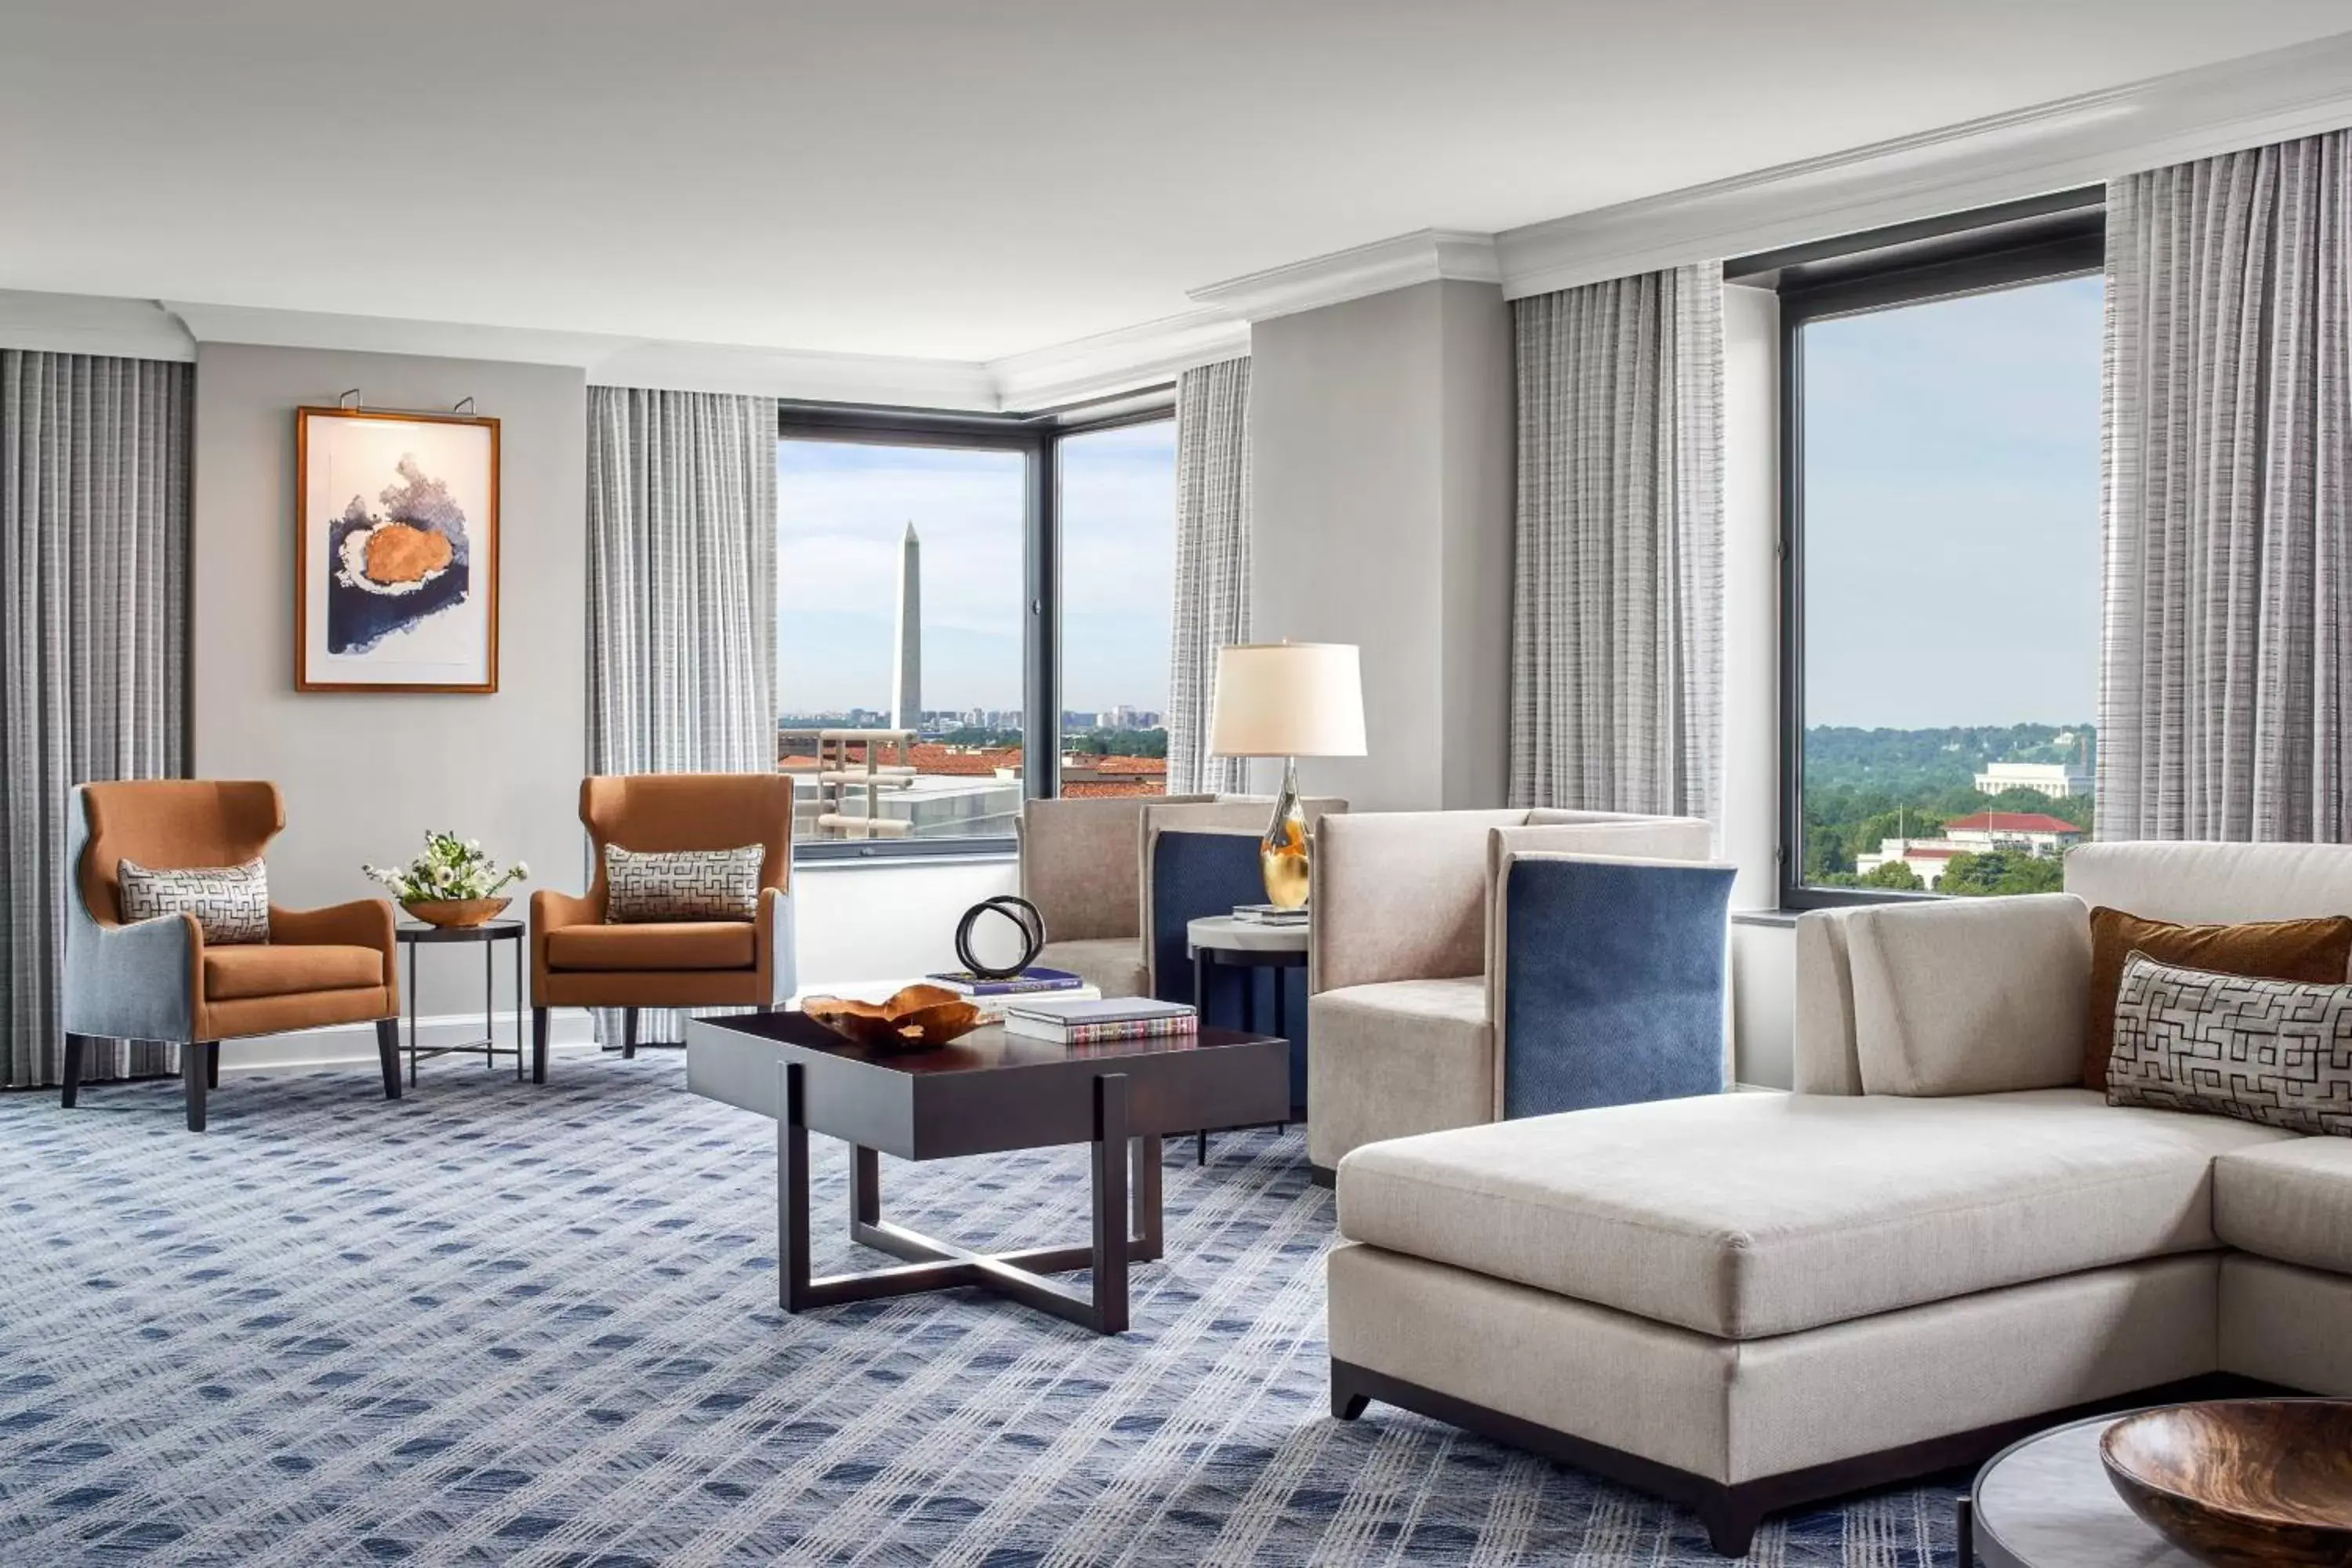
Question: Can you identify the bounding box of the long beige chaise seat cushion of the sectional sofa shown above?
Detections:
[1315,1091,2288,1340]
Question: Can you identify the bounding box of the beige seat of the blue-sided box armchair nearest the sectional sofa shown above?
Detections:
[1308,975,1496,1166]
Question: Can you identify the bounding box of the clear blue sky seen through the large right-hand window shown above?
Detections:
[1804,278,2103,729]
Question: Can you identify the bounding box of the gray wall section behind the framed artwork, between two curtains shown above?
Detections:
[191,343,588,1015]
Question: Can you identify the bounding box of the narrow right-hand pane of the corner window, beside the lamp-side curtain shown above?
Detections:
[1056,419,1176,794]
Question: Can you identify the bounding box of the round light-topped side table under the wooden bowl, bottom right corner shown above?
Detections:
[1959,1410,2197,1568]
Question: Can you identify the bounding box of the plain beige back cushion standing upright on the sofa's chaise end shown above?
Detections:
[1846,893,2091,1095]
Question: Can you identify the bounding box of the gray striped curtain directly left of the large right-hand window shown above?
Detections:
[1510,266,1724,818]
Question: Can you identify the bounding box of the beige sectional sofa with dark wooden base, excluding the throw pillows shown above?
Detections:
[1317,844,2352,1556]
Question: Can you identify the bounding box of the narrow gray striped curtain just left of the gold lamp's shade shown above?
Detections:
[1169,358,1249,794]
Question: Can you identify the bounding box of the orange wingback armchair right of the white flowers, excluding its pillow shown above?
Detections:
[532,774,795,1083]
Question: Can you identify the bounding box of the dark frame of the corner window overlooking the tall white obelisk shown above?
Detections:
[769,381,1176,865]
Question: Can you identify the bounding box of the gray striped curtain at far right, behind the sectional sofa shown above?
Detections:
[2098,132,2352,844]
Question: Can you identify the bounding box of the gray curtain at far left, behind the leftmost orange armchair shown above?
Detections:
[0,348,195,1088]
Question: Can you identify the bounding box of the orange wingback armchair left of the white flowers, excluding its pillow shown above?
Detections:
[64,779,400,1133]
